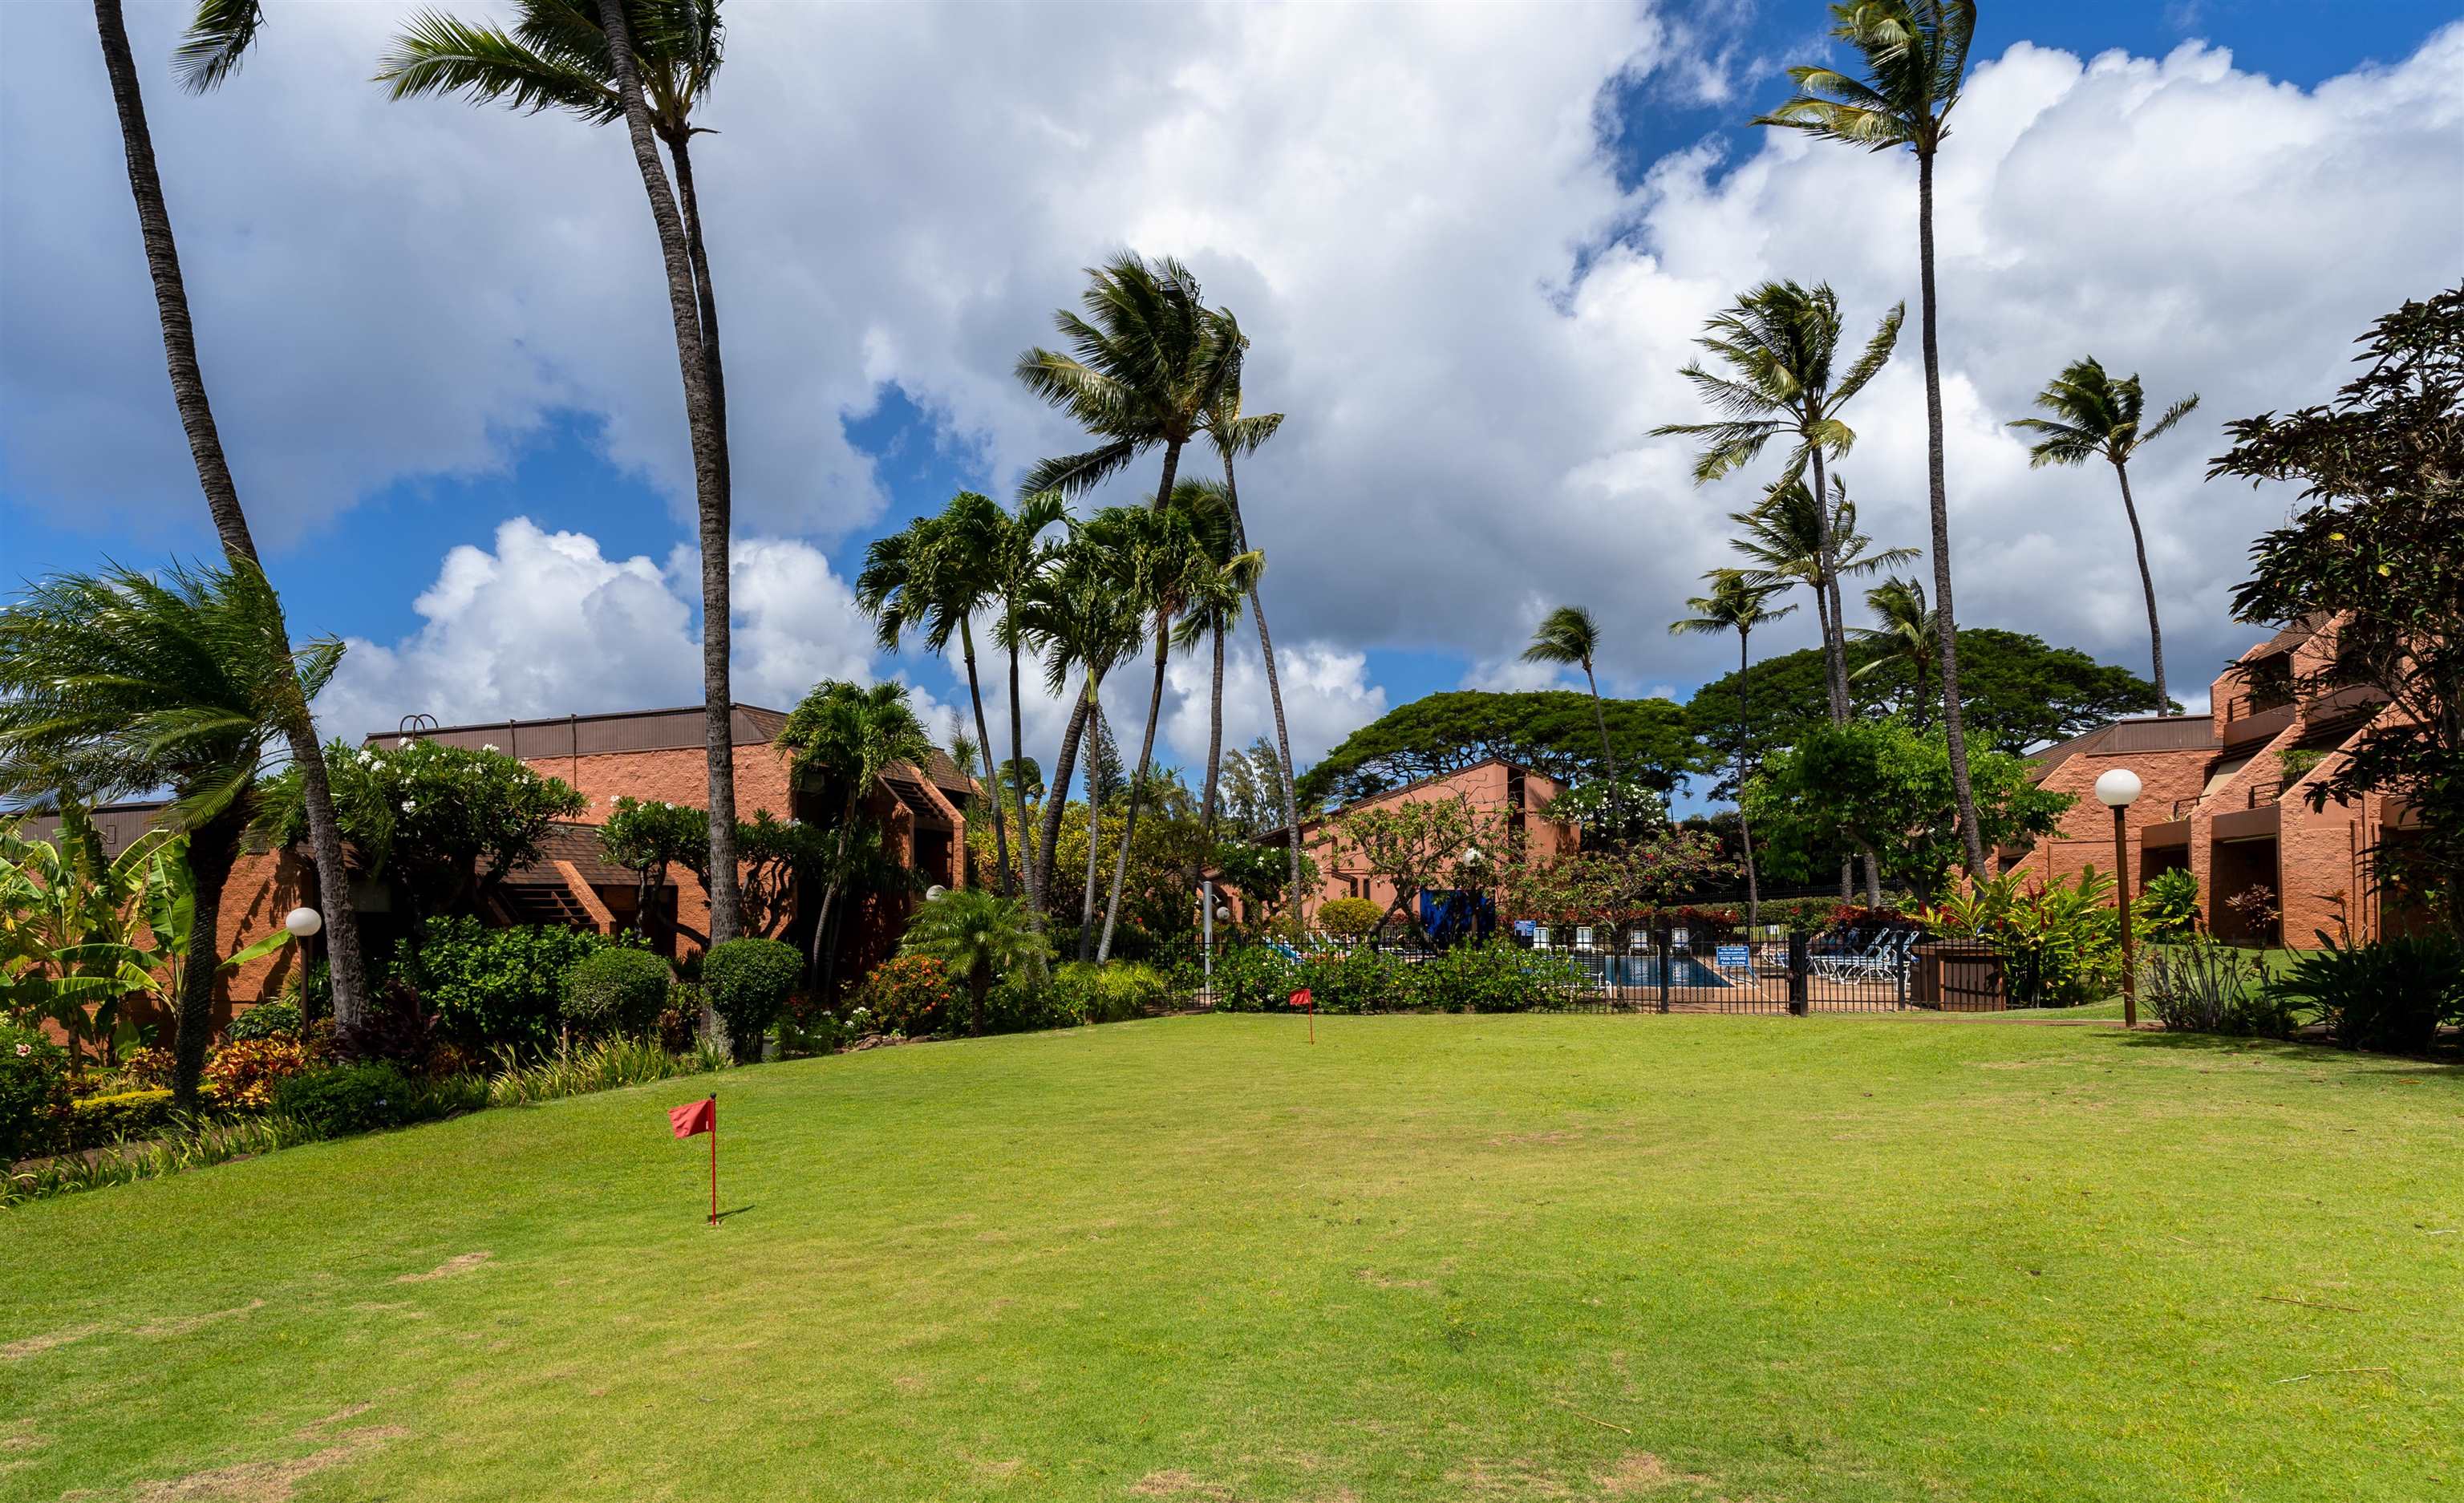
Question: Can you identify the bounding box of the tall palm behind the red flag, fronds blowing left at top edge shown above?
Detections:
[377,0,740,944]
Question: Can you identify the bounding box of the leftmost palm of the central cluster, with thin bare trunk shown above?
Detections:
[855,490,1013,894]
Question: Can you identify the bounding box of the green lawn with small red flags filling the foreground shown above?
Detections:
[0,1015,2464,1503]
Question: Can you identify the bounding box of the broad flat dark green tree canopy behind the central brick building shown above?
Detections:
[1294,690,1695,811]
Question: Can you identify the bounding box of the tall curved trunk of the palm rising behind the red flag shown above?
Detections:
[598,0,744,946]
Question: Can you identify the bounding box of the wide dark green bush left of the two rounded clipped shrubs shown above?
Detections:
[391,919,609,1050]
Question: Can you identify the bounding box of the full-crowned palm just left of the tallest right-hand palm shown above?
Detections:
[1651,281,1907,722]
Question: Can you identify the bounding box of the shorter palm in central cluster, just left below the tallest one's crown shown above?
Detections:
[1018,527,1145,961]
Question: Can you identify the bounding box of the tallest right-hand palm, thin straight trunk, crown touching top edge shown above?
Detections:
[1754,0,1986,880]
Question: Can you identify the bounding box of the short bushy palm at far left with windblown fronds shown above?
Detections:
[0,559,342,1108]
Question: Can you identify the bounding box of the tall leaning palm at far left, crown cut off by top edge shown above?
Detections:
[94,0,367,1027]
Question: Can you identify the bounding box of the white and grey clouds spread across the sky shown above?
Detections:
[0,2,2464,749]
